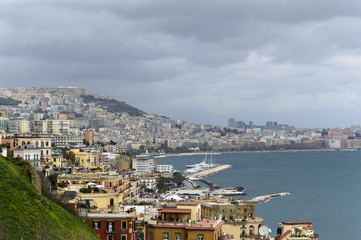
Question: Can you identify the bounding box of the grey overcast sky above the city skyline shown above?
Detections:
[0,0,361,127]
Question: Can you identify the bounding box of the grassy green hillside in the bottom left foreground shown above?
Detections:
[0,156,99,240]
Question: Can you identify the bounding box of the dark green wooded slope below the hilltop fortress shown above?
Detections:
[81,95,145,116]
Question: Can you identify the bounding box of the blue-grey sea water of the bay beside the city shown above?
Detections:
[156,151,361,240]
